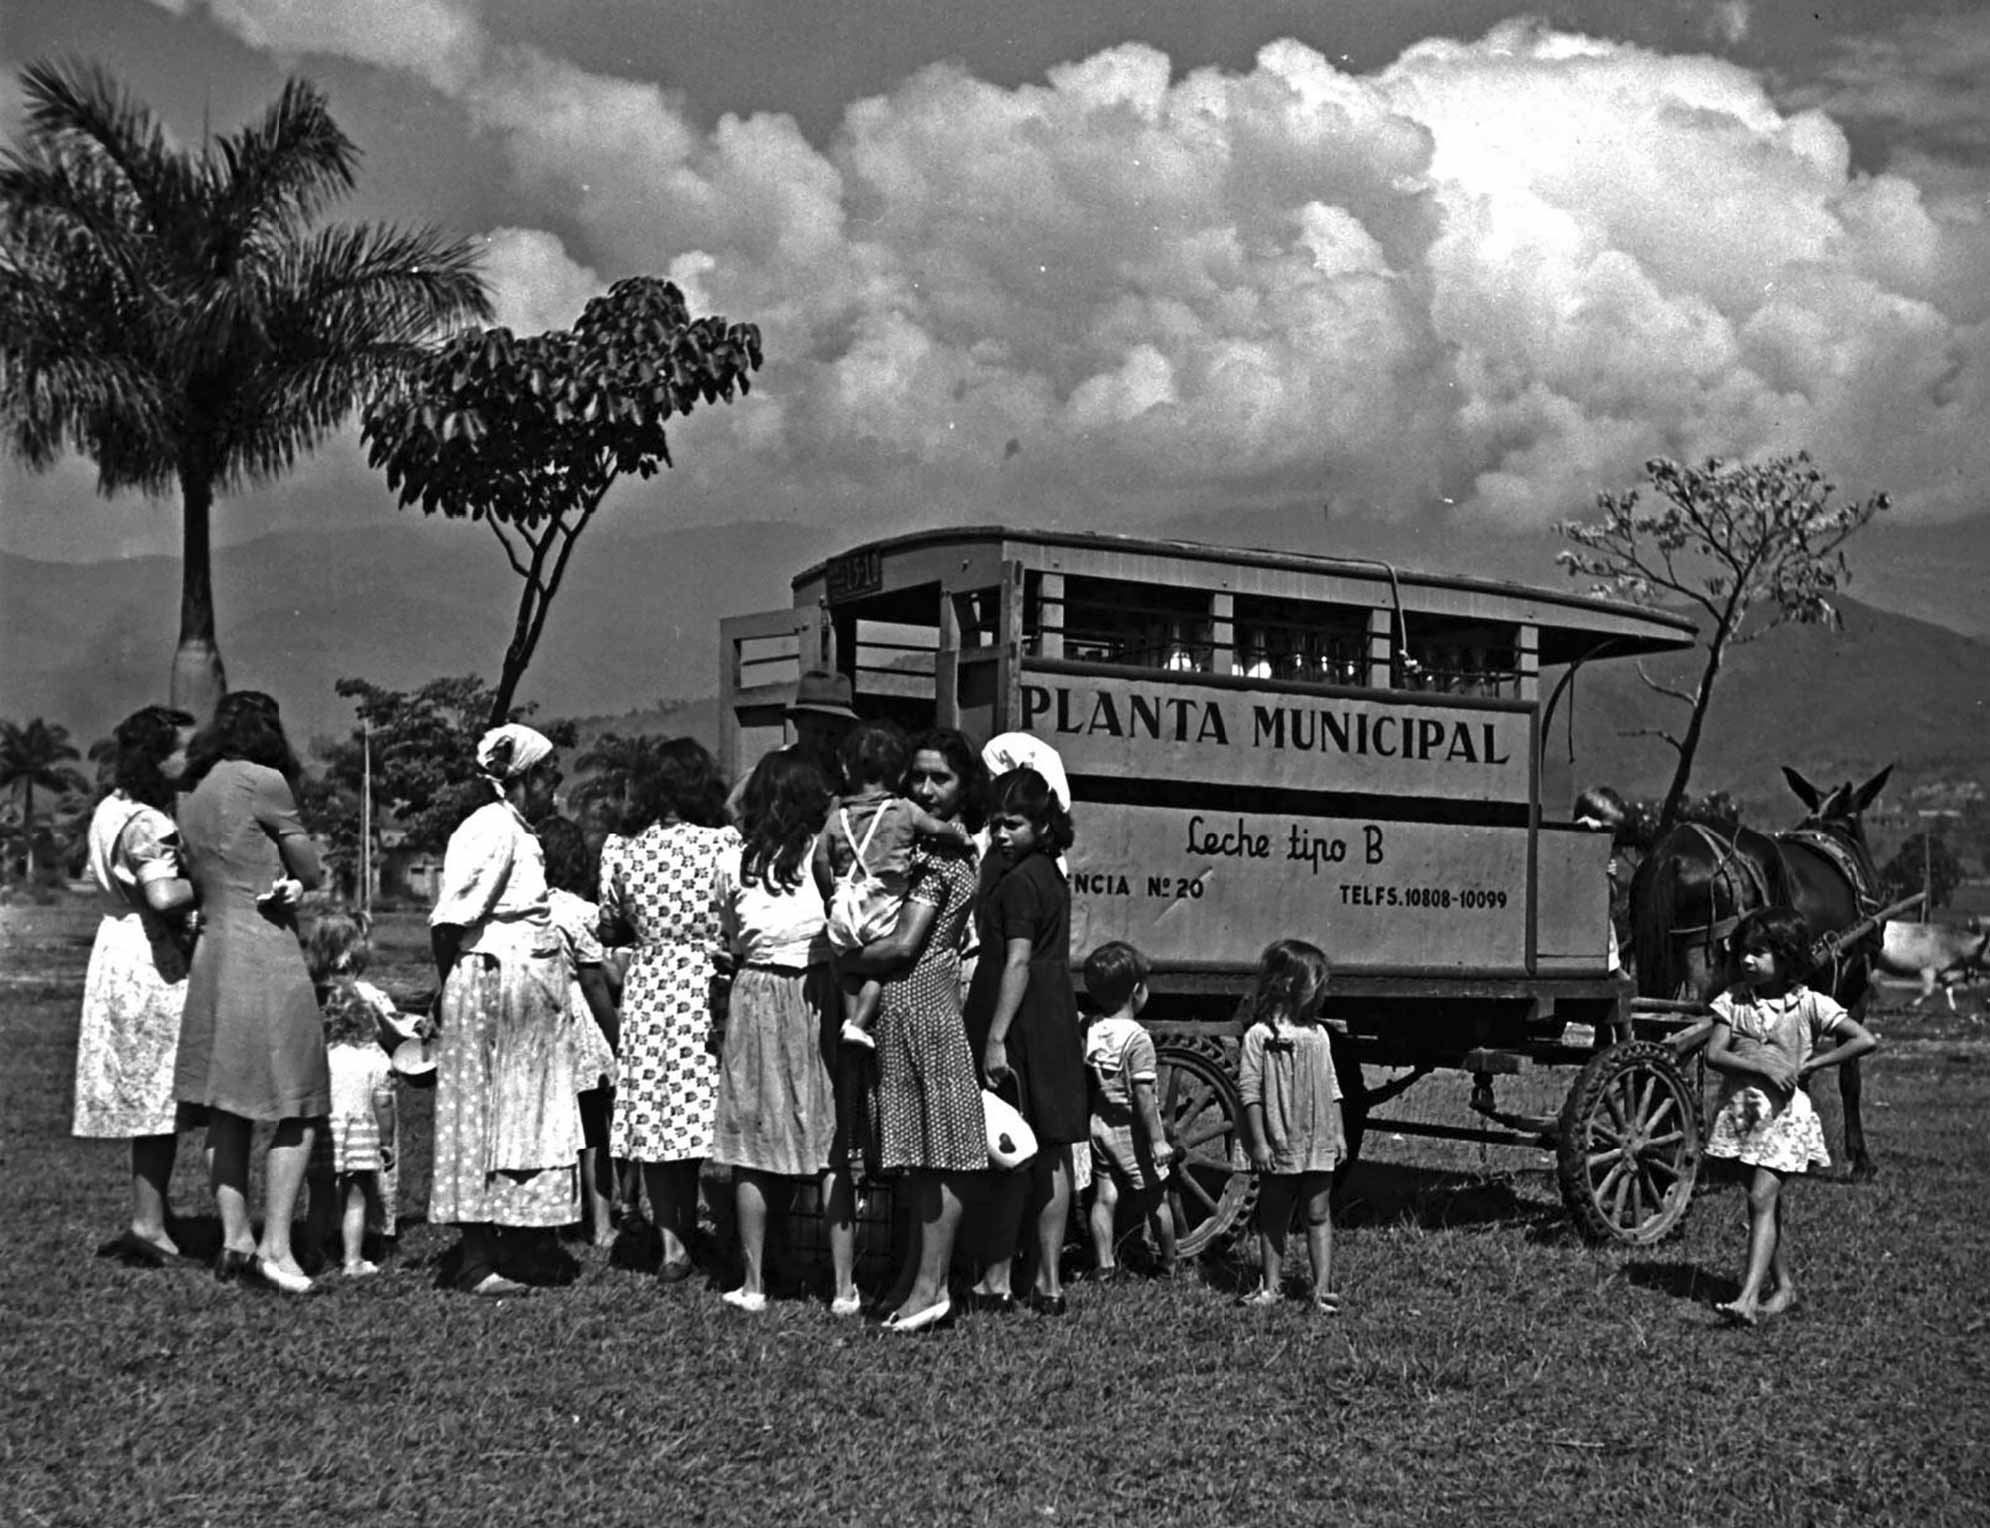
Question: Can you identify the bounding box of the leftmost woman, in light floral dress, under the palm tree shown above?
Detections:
[74,706,193,1267]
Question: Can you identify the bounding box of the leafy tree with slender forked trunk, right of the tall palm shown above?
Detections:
[362,277,760,720]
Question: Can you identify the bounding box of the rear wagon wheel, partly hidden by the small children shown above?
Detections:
[1156,1037,1258,1257]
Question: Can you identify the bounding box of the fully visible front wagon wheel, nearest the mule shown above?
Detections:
[1556,1041,1699,1245]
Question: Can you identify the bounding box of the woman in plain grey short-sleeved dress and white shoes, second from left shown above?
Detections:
[173,690,332,1293]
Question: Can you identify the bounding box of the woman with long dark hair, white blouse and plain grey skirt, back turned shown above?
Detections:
[712,750,835,1313]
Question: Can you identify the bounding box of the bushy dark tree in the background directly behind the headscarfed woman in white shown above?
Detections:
[300,674,575,881]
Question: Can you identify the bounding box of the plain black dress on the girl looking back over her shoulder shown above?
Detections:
[967,854,1093,1146]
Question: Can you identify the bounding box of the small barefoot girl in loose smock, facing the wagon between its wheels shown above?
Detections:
[1240,939,1347,1313]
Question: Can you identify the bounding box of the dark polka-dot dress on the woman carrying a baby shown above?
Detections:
[874,850,989,1172]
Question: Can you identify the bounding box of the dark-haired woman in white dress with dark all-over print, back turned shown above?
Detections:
[599,738,740,1283]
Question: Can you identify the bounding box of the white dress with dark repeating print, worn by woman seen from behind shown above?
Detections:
[601,822,740,1162]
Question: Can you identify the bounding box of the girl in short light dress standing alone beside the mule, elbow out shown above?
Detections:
[1707,907,1879,1325]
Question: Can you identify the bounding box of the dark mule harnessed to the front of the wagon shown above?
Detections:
[1630,764,1892,1180]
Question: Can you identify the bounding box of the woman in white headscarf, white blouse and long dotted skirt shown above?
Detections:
[428,722,581,1295]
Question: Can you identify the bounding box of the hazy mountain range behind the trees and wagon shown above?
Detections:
[0,521,1990,835]
